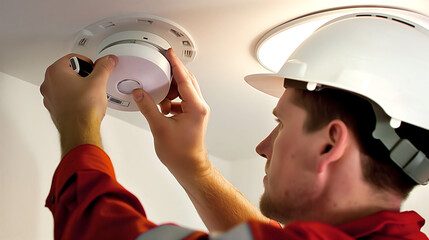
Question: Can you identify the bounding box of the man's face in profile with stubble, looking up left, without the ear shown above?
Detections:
[256,88,320,223]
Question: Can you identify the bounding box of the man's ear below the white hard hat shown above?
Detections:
[318,120,350,173]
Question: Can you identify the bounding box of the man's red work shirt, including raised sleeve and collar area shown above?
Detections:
[46,145,428,240]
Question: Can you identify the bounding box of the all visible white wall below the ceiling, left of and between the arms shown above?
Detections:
[0,73,230,240]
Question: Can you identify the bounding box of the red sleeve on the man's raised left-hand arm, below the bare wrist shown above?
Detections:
[46,145,156,239]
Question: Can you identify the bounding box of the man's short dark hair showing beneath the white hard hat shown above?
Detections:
[293,88,420,199]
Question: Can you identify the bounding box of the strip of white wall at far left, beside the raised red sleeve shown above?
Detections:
[0,73,60,240]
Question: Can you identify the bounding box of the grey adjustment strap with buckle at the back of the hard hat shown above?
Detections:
[372,103,429,184]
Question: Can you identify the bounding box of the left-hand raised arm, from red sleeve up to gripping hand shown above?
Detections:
[40,54,155,240]
